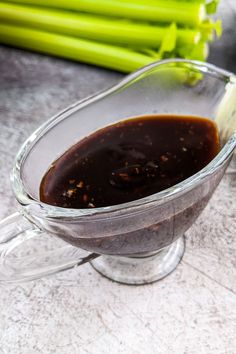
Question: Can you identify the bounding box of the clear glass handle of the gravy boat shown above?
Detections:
[0,212,99,284]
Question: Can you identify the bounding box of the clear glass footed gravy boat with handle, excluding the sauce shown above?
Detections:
[0,59,236,284]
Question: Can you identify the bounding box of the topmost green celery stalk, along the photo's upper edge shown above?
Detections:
[3,0,206,27]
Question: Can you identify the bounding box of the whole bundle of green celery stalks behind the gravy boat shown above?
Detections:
[0,0,221,72]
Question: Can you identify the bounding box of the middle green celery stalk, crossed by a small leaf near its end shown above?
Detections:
[0,2,201,48]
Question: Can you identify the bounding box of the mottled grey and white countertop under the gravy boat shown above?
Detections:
[0,0,236,354]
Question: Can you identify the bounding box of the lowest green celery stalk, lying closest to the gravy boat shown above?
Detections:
[0,24,154,72]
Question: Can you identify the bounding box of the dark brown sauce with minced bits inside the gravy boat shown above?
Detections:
[40,115,220,209]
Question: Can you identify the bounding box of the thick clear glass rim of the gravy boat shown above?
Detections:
[11,59,236,219]
